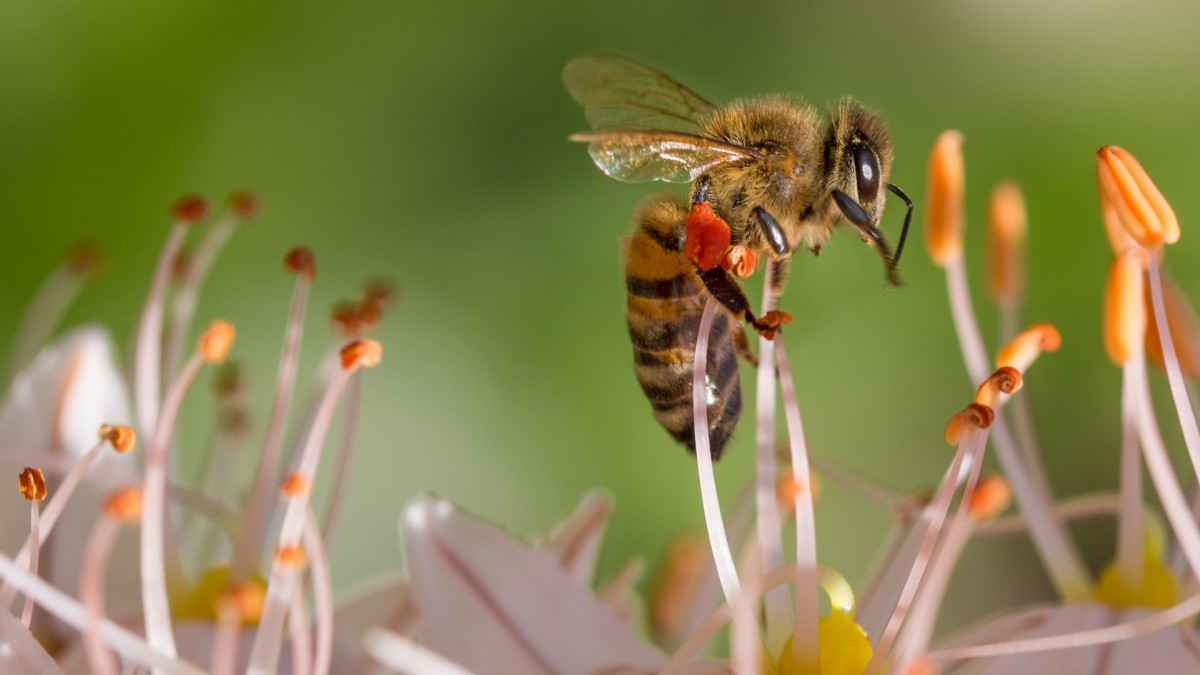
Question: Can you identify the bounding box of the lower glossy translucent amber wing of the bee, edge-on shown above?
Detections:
[570,130,756,183]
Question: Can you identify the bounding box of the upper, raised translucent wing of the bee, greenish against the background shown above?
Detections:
[563,55,715,132]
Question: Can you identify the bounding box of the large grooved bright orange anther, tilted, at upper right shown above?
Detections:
[1096,145,1180,249]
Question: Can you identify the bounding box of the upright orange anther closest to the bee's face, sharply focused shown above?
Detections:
[925,130,966,267]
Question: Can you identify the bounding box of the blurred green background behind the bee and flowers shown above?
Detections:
[0,0,1200,629]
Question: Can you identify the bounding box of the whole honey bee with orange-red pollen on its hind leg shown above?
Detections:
[563,55,912,459]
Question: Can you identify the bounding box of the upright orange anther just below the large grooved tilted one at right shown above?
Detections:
[1104,249,1146,365]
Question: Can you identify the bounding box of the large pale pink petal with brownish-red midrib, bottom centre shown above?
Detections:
[403,498,664,675]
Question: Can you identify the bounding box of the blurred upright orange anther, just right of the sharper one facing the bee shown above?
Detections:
[988,183,1027,304]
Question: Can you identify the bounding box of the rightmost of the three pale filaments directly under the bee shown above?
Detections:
[767,339,821,663]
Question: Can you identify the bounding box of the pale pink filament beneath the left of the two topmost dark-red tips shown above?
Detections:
[133,220,188,438]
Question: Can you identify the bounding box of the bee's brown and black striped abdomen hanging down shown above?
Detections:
[625,198,742,459]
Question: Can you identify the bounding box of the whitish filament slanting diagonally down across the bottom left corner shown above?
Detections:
[0,554,204,675]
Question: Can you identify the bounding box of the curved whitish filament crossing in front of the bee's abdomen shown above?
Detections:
[691,298,734,602]
